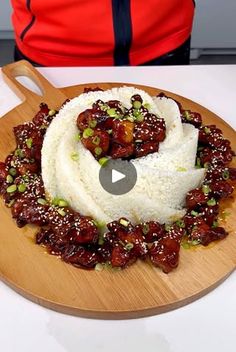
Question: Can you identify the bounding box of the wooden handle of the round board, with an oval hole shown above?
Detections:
[2,60,65,105]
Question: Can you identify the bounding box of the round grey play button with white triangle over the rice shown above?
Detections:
[99,159,137,195]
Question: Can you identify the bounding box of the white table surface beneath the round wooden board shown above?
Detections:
[0,65,236,352]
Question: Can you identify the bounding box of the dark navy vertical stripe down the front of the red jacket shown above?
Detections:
[112,0,132,66]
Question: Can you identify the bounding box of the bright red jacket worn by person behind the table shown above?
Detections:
[12,0,194,66]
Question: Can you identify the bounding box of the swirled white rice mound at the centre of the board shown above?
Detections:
[42,87,205,224]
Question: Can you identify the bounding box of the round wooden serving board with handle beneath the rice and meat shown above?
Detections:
[0,61,236,319]
